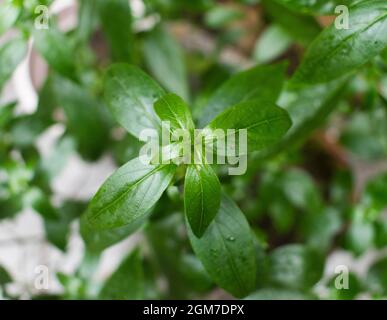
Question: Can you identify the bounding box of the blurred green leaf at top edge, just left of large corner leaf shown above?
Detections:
[262,0,321,45]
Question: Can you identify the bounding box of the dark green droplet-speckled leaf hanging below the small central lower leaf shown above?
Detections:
[187,195,256,298]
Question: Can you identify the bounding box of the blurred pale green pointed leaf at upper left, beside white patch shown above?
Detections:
[33,26,77,80]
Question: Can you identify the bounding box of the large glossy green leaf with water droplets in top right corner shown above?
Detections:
[292,0,387,84]
